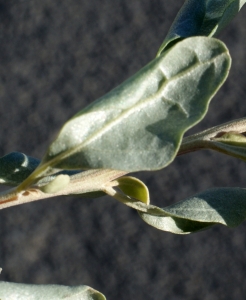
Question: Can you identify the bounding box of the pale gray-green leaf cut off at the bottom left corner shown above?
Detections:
[0,282,106,300]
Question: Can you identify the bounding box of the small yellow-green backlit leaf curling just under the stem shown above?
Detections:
[116,176,149,205]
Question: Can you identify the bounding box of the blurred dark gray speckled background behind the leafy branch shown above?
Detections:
[0,0,246,300]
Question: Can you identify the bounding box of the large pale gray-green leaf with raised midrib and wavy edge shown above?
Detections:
[29,37,230,178]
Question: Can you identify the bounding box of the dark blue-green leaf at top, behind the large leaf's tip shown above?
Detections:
[157,0,246,56]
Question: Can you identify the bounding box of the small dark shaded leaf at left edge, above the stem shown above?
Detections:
[0,152,40,186]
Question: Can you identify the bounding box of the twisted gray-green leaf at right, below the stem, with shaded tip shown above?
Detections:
[139,188,246,234]
